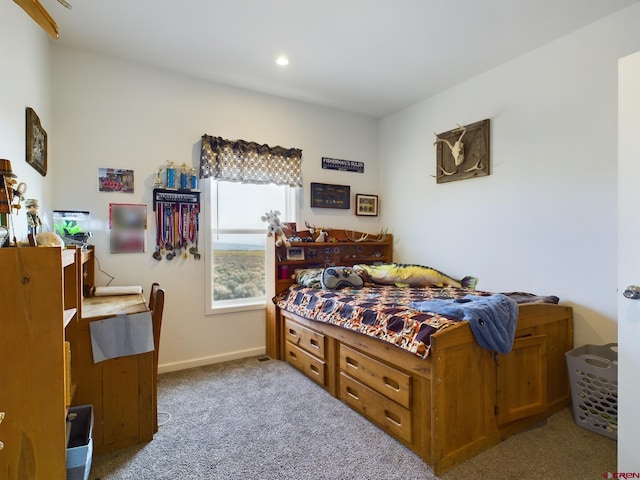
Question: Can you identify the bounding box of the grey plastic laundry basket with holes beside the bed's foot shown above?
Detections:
[565,343,618,439]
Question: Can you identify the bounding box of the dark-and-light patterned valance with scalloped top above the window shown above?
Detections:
[200,135,302,187]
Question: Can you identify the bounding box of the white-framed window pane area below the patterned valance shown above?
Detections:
[205,181,296,313]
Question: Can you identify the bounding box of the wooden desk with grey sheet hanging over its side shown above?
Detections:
[73,288,156,454]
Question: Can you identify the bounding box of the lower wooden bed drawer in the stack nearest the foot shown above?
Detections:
[340,372,412,443]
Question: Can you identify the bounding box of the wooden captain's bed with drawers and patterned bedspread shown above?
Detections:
[267,232,573,475]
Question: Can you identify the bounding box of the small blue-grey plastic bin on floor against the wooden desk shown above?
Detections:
[67,405,93,480]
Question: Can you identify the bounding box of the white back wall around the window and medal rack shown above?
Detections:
[53,46,378,371]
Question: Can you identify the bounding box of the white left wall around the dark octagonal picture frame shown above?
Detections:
[0,2,57,234]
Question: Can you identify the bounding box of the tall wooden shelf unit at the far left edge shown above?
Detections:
[0,248,82,480]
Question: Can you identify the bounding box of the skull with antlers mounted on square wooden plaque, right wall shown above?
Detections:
[433,119,490,183]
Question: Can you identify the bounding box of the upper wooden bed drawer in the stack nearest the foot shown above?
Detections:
[340,345,411,408]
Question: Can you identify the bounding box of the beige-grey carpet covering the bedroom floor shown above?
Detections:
[89,358,616,480]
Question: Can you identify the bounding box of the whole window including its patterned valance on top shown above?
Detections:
[200,135,302,313]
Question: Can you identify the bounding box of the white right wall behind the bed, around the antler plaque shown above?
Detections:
[379,4,640,346]
